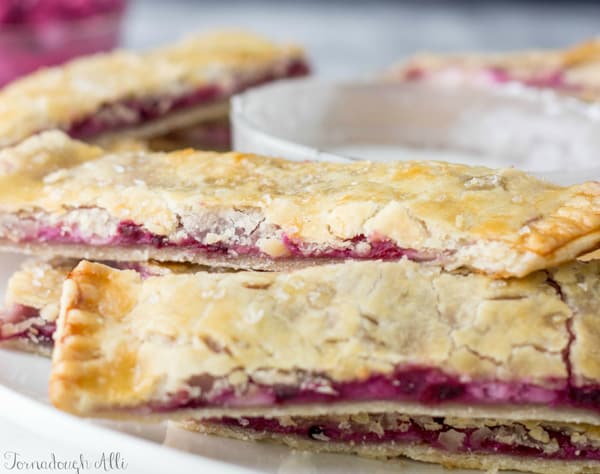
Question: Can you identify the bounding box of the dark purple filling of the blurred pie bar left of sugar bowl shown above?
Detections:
[67,60,309,139]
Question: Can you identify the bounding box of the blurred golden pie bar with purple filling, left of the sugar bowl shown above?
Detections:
[0,32,309,147]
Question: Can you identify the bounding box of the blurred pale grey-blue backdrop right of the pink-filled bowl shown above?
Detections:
[124,0,600,77]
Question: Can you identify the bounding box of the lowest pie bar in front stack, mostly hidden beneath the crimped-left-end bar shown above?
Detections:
[188,412,600,474]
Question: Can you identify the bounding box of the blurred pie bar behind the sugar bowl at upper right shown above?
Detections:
[386,40,600,100]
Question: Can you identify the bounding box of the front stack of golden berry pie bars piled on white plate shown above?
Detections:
[0,131,600,473]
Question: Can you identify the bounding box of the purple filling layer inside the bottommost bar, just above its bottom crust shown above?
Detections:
[209,417,600,461]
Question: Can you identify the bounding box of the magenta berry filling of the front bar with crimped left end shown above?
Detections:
[145,366,600,412]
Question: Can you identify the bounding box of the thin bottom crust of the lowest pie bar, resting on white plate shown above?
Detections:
[188,420,598,474]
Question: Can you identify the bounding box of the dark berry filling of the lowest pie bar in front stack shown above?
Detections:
[208,414,600,461]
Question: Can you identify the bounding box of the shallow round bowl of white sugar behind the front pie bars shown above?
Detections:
[232,79,600,184]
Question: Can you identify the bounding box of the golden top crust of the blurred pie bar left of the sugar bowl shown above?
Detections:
[0,31,308,147]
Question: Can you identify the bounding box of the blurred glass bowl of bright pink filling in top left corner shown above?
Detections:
[0,0,125,86]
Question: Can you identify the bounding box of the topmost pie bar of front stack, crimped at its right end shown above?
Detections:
[0,132,600,277]
